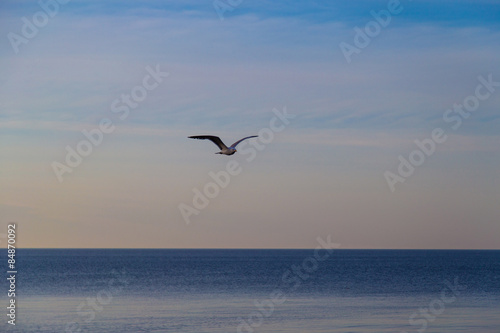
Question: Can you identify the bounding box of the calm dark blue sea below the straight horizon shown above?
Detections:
[0,249,500,333]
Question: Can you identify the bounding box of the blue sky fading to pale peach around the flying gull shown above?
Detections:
[0,0,500,249]
